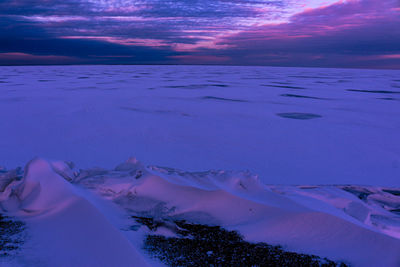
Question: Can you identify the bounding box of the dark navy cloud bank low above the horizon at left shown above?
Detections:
[0,17,181,65]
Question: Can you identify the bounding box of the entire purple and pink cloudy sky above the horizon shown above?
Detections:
[0,0,400,69]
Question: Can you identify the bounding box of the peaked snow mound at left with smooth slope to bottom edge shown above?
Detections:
[0,159,147,267]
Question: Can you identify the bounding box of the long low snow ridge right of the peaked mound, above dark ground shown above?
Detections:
[71,159,400,266]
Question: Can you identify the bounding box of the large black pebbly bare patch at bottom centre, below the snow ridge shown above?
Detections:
[143,220,347,267]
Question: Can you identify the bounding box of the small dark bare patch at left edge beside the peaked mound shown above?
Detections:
[0,214,25,258]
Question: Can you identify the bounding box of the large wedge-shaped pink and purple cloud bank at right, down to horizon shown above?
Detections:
[216,0,400,67]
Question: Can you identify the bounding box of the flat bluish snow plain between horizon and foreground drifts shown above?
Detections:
[0,66,400,186]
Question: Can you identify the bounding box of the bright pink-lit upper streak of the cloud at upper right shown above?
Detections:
[223,0,399,42]
